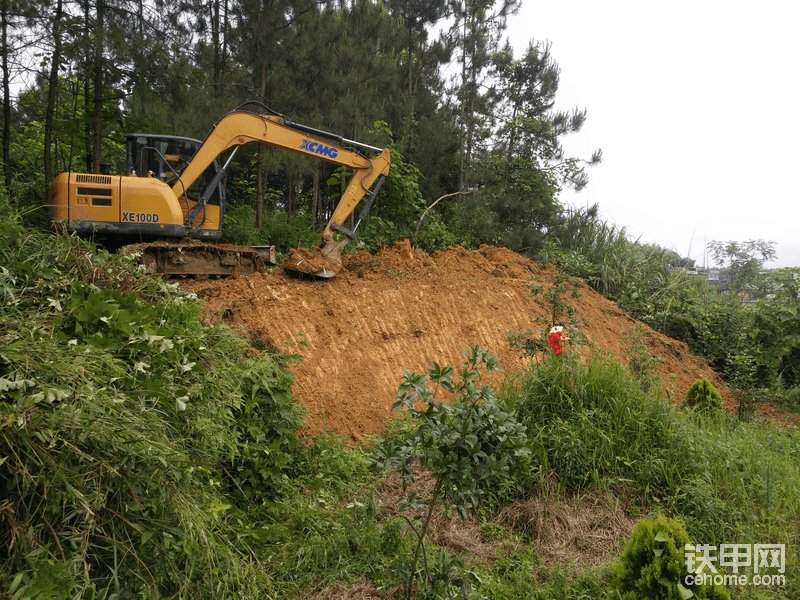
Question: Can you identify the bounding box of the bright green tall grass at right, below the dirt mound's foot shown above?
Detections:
[508,354,800,597]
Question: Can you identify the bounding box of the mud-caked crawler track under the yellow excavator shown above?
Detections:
[125,240,277,277]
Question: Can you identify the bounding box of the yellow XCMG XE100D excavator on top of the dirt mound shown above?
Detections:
[48,102,391,278]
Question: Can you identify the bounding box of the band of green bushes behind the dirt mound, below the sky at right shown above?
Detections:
[542,221,800,389]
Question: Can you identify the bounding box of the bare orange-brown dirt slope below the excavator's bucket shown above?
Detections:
[180,241,788,439]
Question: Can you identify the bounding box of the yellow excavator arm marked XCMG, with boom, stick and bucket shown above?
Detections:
[171,109,391,277]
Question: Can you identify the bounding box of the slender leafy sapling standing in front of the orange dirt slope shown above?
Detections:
[372,345,530,597]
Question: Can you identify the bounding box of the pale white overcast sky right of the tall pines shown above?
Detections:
[506,0,800,268]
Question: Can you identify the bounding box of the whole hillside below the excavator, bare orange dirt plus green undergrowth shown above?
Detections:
[0,222,800,600]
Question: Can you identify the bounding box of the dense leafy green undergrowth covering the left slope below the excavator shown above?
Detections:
[0,220,299,597]
